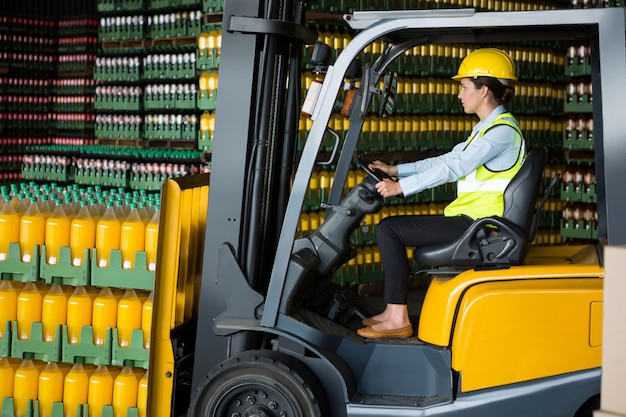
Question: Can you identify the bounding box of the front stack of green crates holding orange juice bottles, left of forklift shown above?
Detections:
[0,183,160,417]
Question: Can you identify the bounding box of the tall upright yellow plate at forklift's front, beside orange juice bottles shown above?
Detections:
[148,174,209,417]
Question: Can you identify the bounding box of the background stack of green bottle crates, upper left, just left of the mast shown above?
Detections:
[94,0,202,148]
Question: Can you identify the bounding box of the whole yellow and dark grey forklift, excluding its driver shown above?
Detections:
[148,4,626,417]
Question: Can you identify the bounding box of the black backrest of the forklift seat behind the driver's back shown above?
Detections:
[502,147,548,233]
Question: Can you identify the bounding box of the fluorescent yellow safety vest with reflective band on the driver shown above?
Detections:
[444,112,526,219]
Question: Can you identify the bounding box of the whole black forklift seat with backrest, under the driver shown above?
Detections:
[414,147,544,268]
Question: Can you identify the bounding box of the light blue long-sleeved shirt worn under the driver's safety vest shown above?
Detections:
[398,105,520,196]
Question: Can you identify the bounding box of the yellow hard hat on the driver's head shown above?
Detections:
[452,48,517,81]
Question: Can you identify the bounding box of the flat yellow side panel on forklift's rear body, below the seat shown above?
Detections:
[452,278,602,392]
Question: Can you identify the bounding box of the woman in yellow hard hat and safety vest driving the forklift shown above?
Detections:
[357,48,525,339]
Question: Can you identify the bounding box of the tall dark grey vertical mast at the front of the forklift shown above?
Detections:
[188,0,317,394]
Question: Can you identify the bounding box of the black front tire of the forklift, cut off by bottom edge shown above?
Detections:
[190,350,328,417]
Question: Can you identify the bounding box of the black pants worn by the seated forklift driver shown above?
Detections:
[376,215,473,304]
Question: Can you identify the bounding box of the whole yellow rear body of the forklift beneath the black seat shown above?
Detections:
[419,246,604,392]
